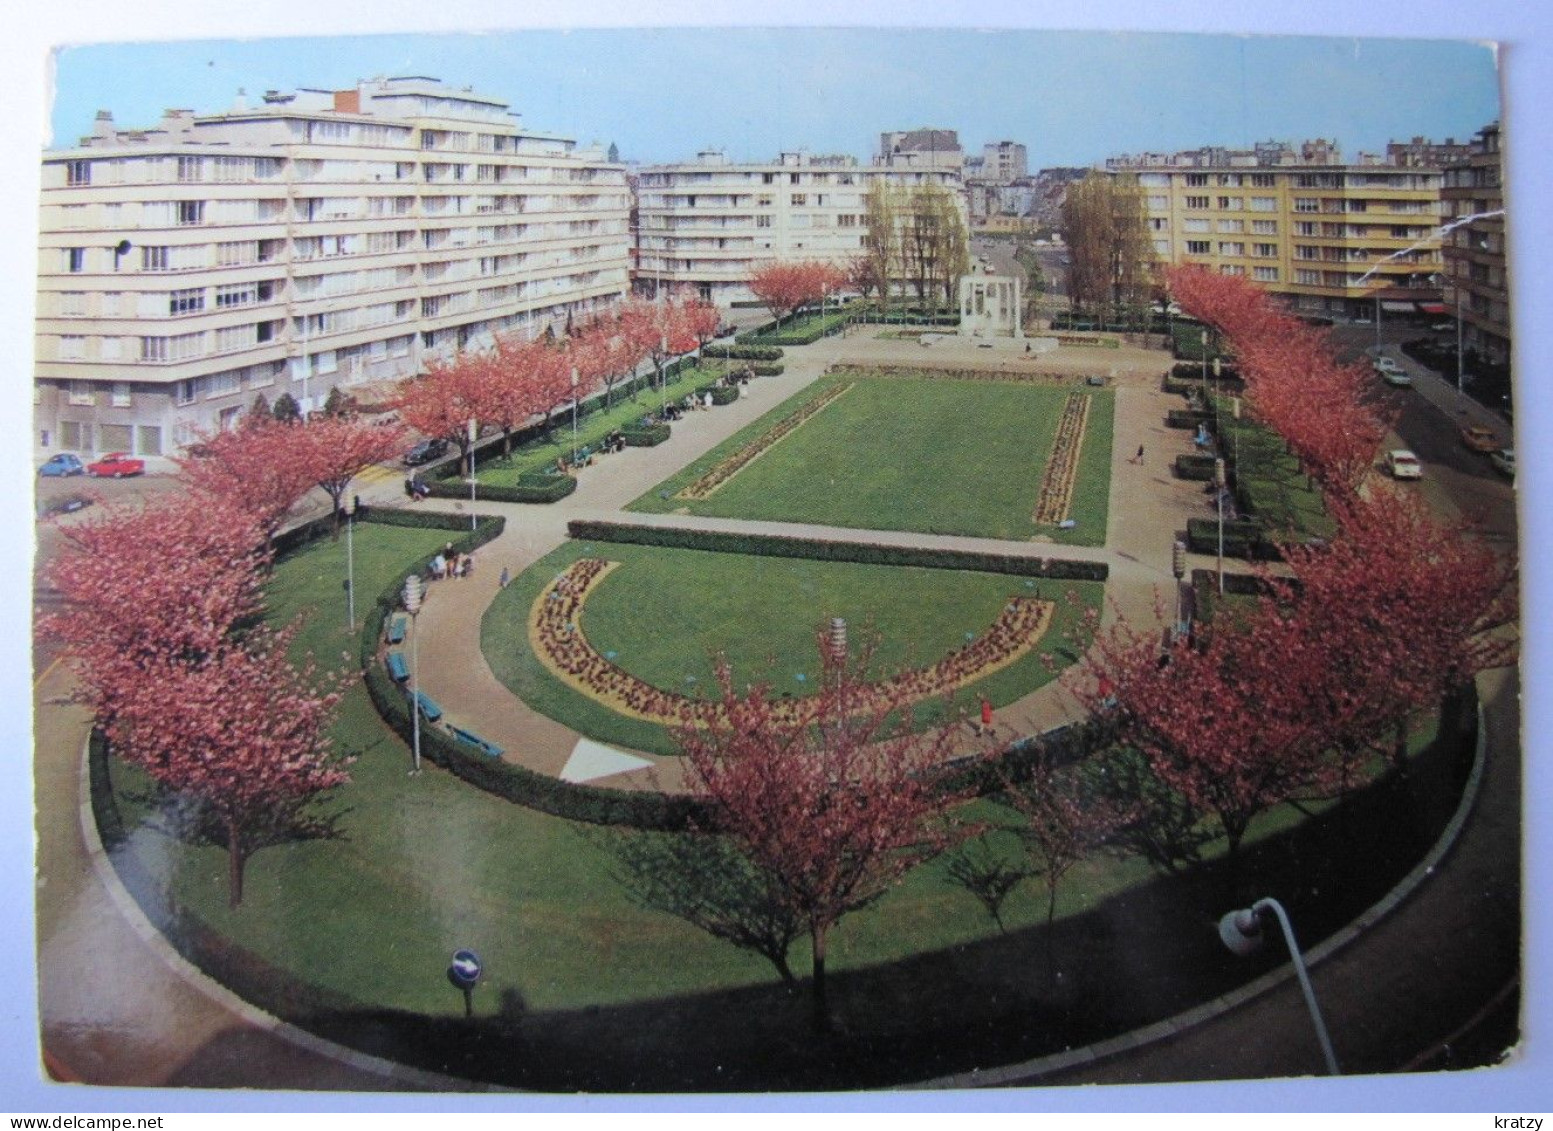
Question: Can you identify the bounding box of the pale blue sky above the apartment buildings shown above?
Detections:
[51,28,1499,166]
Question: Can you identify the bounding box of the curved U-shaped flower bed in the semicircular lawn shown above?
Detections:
[528,558,1054,727]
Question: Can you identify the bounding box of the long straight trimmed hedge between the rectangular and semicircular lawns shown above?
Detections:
[567,519,1110,581]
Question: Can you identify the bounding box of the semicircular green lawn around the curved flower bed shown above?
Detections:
[480,542,1103,753]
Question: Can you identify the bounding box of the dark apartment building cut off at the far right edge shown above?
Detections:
[1440,121,1510,365]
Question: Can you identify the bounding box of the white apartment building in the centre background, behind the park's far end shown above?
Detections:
[637,149,964,308]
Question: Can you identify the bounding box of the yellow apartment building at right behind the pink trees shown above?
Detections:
[1106,140,1444,318]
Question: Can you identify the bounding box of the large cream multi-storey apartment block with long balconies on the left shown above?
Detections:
[34,76,631,457]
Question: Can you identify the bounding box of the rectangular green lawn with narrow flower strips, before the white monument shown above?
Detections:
[631,378,1115,545]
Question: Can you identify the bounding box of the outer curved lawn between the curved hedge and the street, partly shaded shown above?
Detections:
[103,527,1472,1091]
